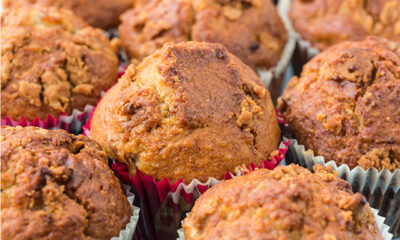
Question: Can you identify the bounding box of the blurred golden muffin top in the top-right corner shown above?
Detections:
[289,0,400,50]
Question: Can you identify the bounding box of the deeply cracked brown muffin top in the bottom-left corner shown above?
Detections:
[0,127,132,240]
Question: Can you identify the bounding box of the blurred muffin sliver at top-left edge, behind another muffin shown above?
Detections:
[3,0,134,29]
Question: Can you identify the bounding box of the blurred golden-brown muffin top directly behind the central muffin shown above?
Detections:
[119,0,287,68]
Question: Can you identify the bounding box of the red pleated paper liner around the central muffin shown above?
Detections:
[83,109,290,239]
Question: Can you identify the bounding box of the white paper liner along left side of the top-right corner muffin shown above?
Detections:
[278,0,320,75]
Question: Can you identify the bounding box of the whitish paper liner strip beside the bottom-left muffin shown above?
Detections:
[111,184,140,240]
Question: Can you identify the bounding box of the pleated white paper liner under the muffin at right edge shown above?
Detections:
[286,139,400,236]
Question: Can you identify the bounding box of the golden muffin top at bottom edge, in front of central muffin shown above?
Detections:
[183,164,382,240]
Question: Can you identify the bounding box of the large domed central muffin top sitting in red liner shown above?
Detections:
[90,42,280,183]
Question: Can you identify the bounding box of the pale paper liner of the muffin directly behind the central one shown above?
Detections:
[256,2,296,103]
